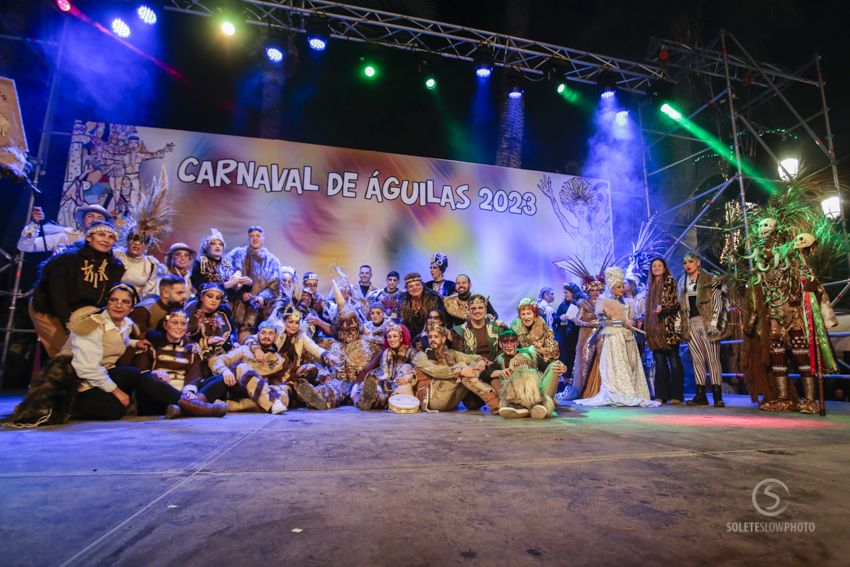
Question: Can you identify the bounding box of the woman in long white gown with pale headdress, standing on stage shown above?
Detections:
[574,266,661,407]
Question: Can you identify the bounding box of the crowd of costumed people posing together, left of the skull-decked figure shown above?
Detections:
[4,200,828,422]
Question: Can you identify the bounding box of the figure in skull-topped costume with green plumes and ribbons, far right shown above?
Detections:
[741,187,844,413]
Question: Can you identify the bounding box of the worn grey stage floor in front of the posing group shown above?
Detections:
[0,396,850,567]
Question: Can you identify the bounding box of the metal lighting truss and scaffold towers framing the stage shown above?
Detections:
[0,0,850,386]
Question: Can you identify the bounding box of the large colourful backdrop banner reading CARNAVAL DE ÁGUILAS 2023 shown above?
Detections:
[63,121,613,318]
